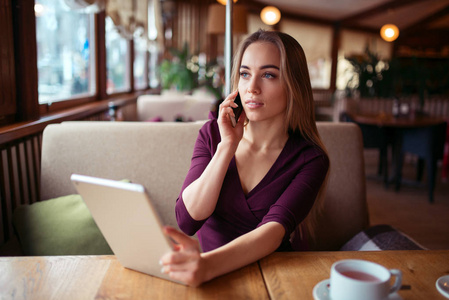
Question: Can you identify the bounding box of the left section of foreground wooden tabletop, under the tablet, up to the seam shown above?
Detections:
[0,256,268,300]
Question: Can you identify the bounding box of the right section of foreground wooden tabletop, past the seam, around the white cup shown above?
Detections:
[260,250,449,300]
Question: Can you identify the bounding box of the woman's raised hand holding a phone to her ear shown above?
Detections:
[218,91,246,148]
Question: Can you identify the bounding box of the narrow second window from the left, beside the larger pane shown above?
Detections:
[106,17,131,94]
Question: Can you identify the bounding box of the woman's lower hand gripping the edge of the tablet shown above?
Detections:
[160,226,208,287]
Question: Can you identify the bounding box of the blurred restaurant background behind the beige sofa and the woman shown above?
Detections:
[0,0,449,262]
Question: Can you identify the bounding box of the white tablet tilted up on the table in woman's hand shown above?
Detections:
[71,174,182,281]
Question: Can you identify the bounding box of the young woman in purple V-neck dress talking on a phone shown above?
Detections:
[161,30,329,286]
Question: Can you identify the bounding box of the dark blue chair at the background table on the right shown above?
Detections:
[396,122,447,203]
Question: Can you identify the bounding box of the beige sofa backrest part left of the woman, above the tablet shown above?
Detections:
[41,121,203,227]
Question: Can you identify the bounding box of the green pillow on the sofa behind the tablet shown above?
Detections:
[13,195,113,256]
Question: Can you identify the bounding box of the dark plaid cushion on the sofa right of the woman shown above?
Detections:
[340,225,425,251]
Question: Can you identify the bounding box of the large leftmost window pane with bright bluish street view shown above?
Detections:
[35,0,96,104]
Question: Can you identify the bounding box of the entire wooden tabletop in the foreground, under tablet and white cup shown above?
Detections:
[0,250,449,299]
